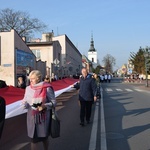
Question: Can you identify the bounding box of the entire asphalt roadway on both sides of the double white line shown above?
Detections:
[0,78,150,150]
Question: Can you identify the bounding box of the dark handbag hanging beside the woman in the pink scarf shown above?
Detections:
[50,108,60,138]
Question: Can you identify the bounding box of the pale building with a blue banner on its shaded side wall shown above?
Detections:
[0,30,39,86]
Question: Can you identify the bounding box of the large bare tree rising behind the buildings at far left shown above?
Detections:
[0,8,47,37]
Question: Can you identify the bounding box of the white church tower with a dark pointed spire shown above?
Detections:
[88,34,98,64]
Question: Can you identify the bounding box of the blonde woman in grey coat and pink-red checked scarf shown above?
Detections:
[23,70,56,150]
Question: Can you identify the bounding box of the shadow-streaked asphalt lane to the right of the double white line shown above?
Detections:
[102,79,150,150]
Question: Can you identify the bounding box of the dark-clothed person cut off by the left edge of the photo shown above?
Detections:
[0,97,6,138]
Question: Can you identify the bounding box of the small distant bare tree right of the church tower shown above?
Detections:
[102,54,116,73]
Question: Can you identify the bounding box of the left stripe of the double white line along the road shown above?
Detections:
[89,96,99,150]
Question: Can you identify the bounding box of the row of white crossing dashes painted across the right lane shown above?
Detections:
[102,88,143,92]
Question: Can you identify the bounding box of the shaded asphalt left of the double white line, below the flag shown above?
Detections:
[0,91,99,150]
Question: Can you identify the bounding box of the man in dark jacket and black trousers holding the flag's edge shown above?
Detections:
[74,68,97,126]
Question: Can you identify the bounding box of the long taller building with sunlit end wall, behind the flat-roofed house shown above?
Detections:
[42,32,82,76]
